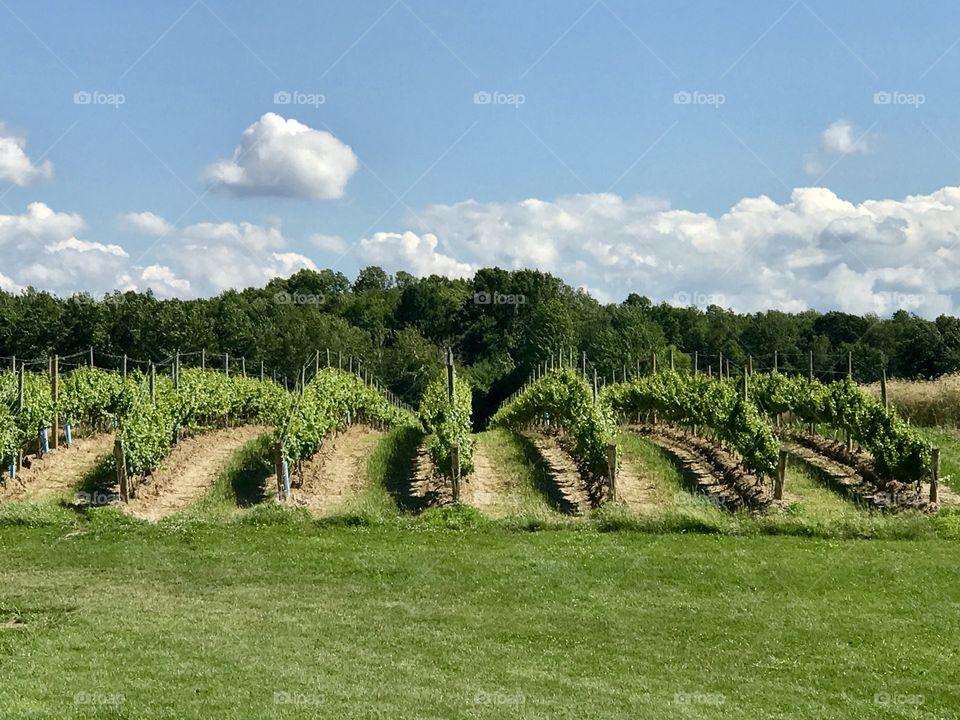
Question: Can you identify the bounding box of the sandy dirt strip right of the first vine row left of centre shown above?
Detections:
[290,425,383,515]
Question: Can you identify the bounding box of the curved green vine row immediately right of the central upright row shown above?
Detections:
[490,368,616,477]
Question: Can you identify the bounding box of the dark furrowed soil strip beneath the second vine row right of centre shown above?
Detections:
[631,424,772,509]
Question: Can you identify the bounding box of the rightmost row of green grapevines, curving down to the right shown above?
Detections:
[751,372,930,482]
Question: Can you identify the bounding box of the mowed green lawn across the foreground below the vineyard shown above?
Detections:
[0,522,960,720]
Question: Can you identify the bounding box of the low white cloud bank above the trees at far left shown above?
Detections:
[0,203,315,297]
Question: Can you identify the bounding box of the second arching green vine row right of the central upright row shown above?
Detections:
[600,370,779,476]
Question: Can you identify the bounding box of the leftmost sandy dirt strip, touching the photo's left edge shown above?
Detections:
[0,433,113,502]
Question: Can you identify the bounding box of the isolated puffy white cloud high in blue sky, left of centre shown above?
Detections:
[204,113,357,200]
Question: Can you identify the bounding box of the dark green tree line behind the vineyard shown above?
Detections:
[0,266,960,422]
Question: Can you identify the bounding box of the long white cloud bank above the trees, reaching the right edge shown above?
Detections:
[358,187,960,317]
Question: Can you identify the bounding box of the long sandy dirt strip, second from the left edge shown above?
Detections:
[122,425,270,521]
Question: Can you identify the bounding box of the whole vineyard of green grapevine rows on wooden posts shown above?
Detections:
[0,351,955,524]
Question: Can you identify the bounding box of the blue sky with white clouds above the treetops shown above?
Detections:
[0,0,960,317]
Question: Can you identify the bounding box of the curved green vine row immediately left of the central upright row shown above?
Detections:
[276,368,416,462]
